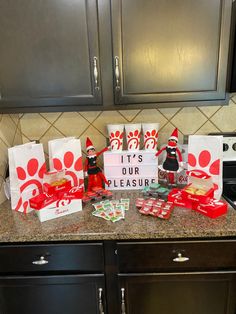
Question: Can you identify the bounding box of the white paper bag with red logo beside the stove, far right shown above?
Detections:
[188,135,223,199]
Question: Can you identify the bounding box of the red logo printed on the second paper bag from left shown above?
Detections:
[52,151,84,186]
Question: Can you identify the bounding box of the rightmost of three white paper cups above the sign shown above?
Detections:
[142,123,159,151]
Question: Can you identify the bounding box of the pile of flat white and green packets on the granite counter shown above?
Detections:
[92,199,129,222]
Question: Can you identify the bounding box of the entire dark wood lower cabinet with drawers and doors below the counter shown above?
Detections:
[0,239,236,314]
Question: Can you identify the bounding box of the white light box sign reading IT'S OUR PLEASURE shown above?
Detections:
[103,150,158,190]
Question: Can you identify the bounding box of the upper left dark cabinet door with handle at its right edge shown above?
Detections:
[0,0,102,111]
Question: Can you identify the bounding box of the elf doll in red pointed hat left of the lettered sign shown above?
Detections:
[84,137,109,191]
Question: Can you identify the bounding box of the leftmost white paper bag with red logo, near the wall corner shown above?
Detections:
[8,142,46,213]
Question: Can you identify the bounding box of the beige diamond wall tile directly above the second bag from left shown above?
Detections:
[54,112,89,137]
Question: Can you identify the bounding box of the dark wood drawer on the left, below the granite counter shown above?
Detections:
[0,243,104,273]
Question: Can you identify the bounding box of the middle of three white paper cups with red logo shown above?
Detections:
[125,123,141,151]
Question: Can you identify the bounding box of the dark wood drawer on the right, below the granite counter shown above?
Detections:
[117,241,236,273]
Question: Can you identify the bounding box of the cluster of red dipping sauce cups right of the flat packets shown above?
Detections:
[135,197,174,219]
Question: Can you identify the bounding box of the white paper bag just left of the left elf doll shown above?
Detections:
[48,137,84,186]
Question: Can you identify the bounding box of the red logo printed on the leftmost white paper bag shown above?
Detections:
[14,158,46,213]
